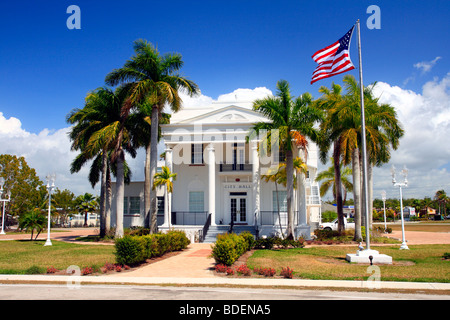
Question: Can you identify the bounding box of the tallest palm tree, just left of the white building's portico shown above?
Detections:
[105,39,198,233]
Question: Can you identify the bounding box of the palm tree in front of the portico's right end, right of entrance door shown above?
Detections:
[249,80,321,238]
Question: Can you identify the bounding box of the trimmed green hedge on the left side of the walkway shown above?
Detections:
[115,230,190,265]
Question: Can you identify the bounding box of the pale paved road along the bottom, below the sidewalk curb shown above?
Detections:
[0,284,450,301]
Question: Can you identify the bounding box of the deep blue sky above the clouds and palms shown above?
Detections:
[0,0,450,198]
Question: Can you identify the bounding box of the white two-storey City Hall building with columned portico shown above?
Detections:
[111,102,320,241]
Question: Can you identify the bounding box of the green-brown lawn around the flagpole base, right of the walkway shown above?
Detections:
[247,245,450,282]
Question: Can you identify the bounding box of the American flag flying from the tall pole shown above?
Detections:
[311,26,355,84]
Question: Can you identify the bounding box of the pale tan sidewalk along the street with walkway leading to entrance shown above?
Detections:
[0,229,450,294]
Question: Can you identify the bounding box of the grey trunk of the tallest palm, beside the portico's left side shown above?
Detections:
[149,104,159,233]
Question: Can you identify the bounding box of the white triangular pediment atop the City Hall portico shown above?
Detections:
[177,105,268,124]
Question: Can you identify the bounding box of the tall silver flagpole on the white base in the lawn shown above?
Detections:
[356,19,370,250]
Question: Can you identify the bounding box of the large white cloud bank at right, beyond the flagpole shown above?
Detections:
[374,73,450,197]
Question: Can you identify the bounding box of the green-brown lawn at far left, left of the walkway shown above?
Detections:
[0,240,115,274]
